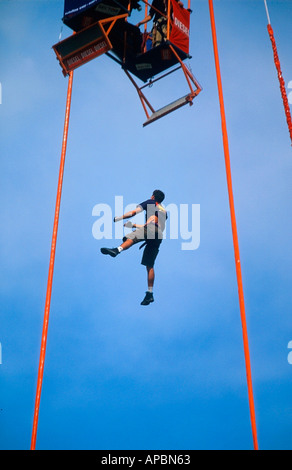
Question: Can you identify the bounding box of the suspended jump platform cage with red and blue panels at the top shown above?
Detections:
[53,0,202,126]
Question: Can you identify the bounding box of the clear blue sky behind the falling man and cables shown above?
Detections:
[0,0,292,450]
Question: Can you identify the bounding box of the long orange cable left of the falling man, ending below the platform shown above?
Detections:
[31,72,73,450]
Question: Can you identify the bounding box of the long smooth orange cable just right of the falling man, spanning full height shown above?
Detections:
[209,0,258,450]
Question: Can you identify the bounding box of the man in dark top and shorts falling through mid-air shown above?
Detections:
[100,189,167,305]
